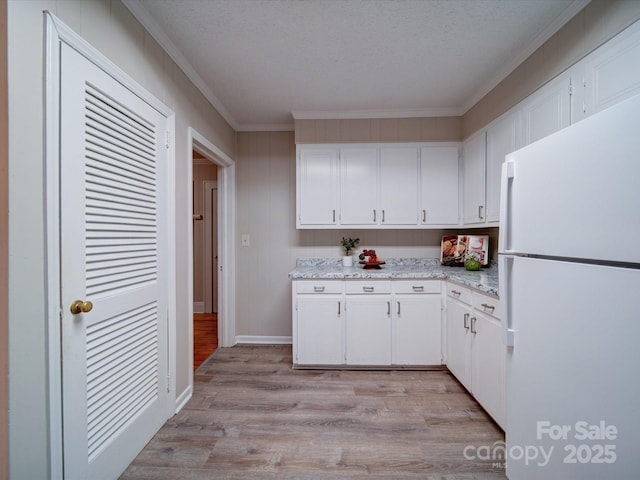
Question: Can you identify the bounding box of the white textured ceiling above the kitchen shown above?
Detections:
[124,0,588,130]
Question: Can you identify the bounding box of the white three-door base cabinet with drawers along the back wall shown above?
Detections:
[293,280,442,367]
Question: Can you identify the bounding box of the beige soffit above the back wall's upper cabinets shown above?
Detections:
[295,117,462,143]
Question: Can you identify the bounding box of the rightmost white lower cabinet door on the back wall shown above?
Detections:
[391,295,442,365]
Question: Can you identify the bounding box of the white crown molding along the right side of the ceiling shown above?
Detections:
[460,0,591,115]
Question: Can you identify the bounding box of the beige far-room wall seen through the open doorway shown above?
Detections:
[193,159,218,302]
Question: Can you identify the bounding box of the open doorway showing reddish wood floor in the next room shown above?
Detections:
[192,150,219,371]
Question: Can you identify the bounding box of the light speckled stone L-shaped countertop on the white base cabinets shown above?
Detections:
[289,257,498,297]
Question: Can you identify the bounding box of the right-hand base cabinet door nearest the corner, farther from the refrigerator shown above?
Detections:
[447,299,471,390]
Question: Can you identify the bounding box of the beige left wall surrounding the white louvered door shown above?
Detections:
[8,0,235,479]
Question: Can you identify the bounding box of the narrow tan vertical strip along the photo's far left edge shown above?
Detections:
[0,0,9,480]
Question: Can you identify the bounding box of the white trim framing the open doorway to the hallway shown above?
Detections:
[187,127,236,386]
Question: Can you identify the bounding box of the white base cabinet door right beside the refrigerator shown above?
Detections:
[470,311,506,427]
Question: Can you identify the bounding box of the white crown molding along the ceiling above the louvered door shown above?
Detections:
[122,0,240,131]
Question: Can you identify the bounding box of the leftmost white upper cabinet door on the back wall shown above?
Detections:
[296,147,339,227]
